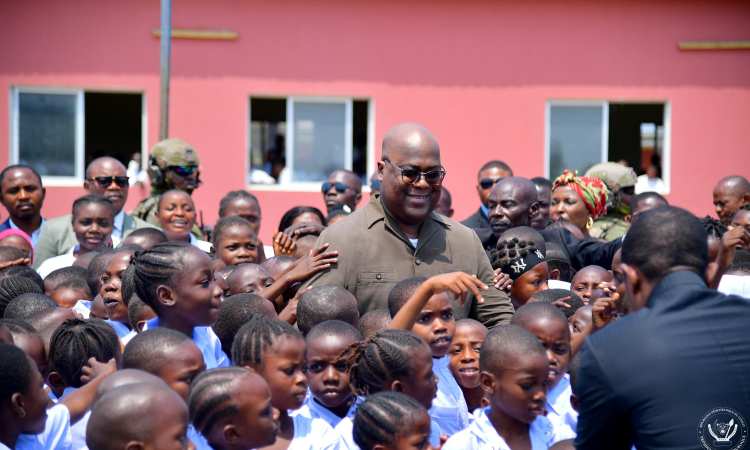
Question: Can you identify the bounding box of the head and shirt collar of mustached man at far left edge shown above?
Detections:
[0,164,45,246]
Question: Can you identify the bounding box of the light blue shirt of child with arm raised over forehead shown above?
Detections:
[430,356,469,436]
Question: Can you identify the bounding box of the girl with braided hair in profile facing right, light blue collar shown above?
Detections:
[123,242,230,370]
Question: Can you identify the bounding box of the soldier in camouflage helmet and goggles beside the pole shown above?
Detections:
[131,138,205,239]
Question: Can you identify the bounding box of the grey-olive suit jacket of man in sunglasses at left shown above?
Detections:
[34,214,156,269]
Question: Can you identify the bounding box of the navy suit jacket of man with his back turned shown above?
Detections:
[575,271,750,450]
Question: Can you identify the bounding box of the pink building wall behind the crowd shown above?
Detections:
[0,0,750,246]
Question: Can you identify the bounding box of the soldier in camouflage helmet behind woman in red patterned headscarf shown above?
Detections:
[585,162,638,241]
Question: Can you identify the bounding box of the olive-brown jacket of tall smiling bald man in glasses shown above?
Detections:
[303,197,514,328]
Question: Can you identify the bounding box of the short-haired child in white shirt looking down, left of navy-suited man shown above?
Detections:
[443,326,553,450]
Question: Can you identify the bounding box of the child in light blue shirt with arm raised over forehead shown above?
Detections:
[388,272,487,435]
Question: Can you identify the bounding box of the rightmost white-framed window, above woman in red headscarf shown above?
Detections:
[544,100,671,194]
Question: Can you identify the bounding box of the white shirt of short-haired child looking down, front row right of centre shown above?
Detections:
[442,406,554,450]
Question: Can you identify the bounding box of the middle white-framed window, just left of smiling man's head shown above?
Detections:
[247,96,374,191]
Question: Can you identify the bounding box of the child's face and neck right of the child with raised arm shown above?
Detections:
[448,319,489,414]
